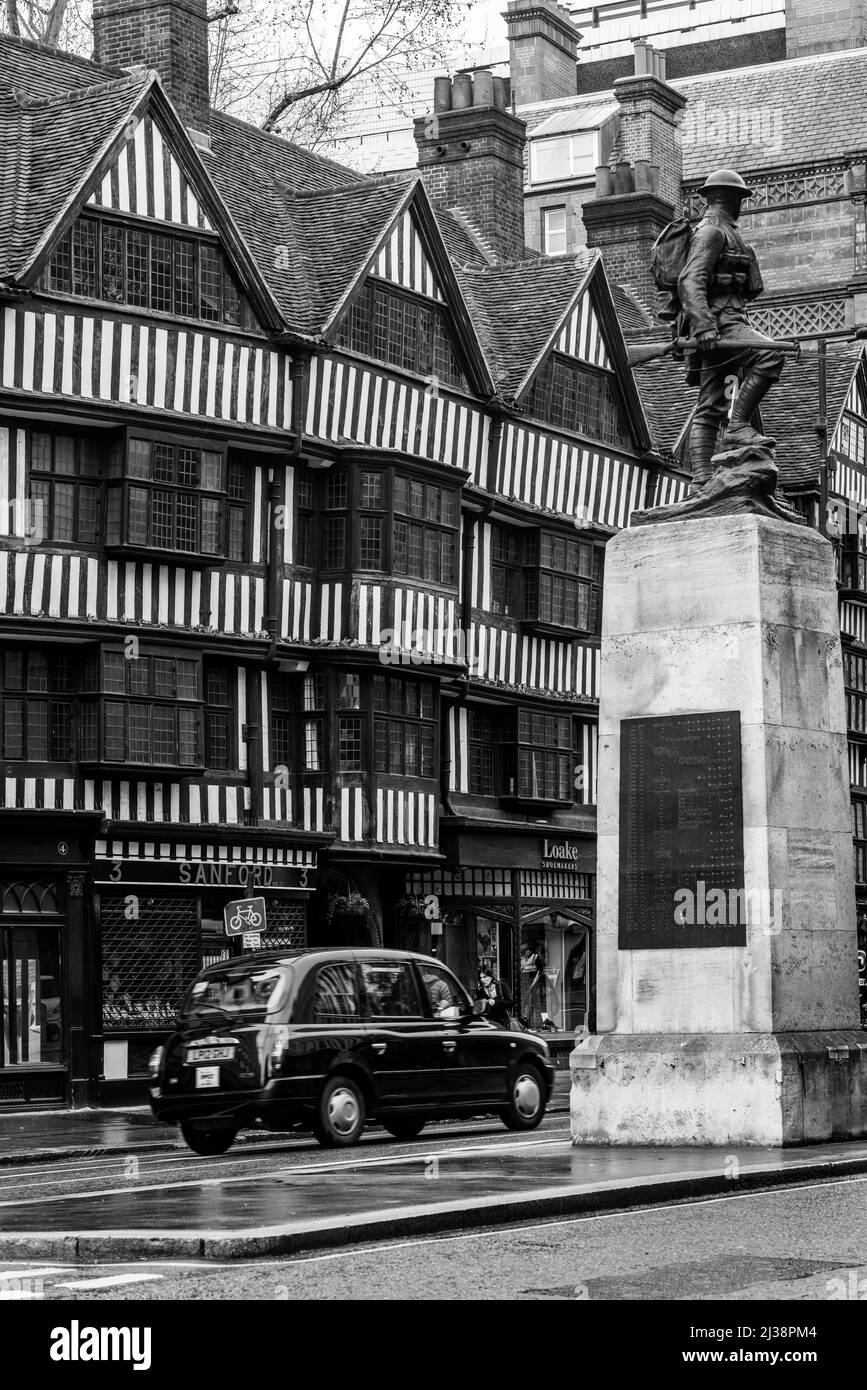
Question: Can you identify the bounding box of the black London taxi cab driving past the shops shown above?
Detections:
[150,948,554,1154]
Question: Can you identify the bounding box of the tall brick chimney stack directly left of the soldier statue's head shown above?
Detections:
[582,43,686,310]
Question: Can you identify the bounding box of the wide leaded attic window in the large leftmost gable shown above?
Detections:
[46,215,257,328]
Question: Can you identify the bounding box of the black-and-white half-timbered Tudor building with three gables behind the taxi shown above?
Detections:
[0,27,685,1104]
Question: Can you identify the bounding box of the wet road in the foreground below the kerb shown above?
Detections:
[0,1177,867,1301]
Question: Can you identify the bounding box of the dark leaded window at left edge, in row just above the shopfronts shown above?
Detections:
[1,648,78,762]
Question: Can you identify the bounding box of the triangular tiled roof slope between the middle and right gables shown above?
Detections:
[457,256,595,398]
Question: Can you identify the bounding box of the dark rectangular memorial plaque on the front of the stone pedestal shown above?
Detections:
[618,710,748,951]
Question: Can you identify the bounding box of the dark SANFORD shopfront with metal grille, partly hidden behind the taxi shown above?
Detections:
[94,842,315,1104]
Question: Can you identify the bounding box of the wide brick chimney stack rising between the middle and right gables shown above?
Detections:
[413,68,527,261]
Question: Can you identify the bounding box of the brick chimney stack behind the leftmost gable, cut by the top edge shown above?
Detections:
[93,0,208,133]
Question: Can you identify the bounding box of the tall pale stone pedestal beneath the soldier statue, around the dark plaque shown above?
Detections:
[571,516,867,1145]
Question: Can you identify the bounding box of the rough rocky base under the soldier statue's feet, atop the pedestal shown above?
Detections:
[631,441,807,527]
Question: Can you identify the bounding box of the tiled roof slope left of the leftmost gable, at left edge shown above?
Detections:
[0,72,150,275]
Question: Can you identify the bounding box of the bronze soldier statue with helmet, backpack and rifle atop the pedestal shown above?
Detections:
[678,170,784,492]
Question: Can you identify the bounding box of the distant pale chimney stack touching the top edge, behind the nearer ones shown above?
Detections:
[503,0,581,106]
